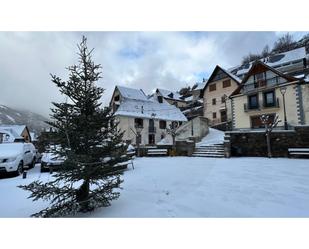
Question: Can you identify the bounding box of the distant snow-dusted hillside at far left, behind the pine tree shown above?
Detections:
[0,105,47,133]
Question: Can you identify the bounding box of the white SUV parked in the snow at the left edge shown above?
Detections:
[0,143,36,175]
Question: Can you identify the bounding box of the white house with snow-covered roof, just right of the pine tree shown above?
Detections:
[110,86,187,145]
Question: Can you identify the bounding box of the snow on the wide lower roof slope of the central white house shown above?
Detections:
[115,99,187,121]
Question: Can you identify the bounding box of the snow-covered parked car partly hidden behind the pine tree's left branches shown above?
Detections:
[41,145,65,172]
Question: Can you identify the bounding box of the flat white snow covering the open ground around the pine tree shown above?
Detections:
[0,157,309,218]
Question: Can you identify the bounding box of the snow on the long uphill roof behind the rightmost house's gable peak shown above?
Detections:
[228,47,306,75]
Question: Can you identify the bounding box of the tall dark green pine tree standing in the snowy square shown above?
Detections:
[19,37,126,217]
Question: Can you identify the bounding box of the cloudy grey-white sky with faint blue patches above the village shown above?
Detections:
[0,32,304,116]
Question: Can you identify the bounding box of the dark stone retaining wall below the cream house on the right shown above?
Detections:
[225,126,309,157]
